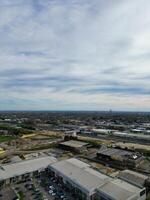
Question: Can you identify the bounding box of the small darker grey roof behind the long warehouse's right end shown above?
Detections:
[119,170,148,186]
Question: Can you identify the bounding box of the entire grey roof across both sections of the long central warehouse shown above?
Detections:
[49,158,145,200]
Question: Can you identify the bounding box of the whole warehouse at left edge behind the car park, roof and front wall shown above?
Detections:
[0,156,57,188]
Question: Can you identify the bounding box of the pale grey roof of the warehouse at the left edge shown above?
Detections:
[0,156,57,180]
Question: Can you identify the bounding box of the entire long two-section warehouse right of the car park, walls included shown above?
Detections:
[49,158,146,200]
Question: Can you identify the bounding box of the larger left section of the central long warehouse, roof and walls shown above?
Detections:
[50,158,109,200]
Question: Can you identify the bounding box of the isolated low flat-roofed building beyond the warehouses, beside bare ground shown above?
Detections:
[60,140,88,153]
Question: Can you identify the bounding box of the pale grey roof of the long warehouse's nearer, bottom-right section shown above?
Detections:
[98,179,144,200]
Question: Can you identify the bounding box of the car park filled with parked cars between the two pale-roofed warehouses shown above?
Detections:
[0,173,79,200]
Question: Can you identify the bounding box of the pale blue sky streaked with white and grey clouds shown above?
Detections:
[0,0,150,111]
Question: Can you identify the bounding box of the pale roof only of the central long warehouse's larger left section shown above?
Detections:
[50,158,110,193]
